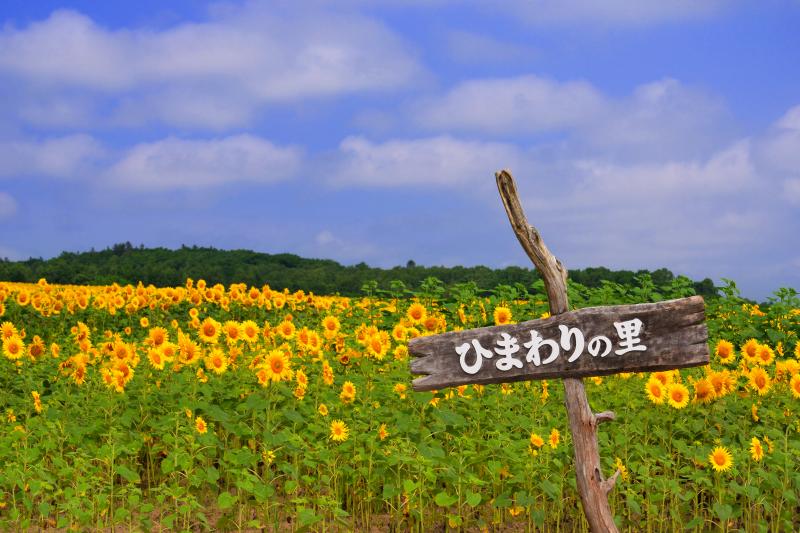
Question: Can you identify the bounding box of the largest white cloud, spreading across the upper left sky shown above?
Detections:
[0,3,421,127]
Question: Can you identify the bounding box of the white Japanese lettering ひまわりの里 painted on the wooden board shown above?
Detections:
[455,318,647,374]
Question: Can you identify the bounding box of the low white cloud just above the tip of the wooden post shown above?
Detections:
[330,136,526,190]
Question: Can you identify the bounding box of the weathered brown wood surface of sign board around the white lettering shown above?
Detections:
[408,296,709,391]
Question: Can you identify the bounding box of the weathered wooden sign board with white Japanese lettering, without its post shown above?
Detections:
[408,296,709,391]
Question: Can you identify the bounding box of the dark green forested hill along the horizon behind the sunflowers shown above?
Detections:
[0,243,716,296]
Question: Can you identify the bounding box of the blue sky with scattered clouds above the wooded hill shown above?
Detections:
[0,0,800,299]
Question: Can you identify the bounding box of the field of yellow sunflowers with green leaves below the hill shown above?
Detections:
[0,276,800,531]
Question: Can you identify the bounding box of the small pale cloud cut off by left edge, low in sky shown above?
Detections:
[0,135,106,178]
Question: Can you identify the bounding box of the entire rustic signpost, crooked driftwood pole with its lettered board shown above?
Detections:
[408,170,709,532]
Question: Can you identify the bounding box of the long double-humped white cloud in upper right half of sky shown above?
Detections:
[413,75,731,160]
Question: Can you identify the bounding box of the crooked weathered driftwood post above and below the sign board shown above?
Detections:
[495,170,620,532]
